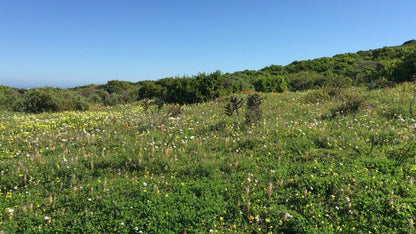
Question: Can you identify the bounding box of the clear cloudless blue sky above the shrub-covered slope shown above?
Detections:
[0,0,416,88]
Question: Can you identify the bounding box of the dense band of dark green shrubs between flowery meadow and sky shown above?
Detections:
[0,40,416,113]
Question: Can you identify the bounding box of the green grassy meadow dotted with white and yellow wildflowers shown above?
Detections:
[0,83,416,233]
